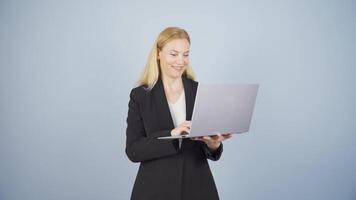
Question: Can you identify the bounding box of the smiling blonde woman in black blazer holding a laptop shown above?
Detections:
[126,27,231,200]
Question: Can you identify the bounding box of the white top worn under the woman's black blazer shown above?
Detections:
[168,91,186,148]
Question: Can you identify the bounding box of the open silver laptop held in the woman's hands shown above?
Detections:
[158,83,259,139]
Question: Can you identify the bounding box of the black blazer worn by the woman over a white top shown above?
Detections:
[126,77,223,200]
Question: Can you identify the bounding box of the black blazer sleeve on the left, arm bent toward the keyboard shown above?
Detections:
[126,90,179,162]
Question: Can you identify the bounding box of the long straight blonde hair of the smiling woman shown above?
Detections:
[138,27,195,90]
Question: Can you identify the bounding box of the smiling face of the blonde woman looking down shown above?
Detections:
[158,39,190,78]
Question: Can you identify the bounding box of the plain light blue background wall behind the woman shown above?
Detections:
[0,0,356,200]
